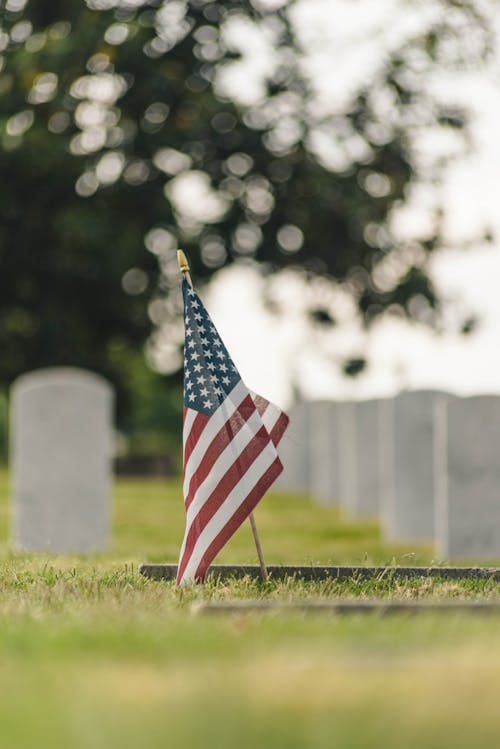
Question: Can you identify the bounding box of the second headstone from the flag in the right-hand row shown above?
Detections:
[308,401,340,505]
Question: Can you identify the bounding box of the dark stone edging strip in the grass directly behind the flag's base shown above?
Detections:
[139,564,500,582]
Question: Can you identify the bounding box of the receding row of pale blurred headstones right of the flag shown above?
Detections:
[280,390,500,560]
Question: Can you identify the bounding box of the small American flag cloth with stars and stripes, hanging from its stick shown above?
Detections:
[177,280,288,585]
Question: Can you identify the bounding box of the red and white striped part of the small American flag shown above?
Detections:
[177,380,288,585]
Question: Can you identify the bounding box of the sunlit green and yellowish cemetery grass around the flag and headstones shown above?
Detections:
[0,474,500,749]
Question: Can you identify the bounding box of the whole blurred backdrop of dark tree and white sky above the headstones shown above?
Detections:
[0,0,500,473]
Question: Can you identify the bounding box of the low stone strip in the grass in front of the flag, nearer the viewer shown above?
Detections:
[191,598,500,616]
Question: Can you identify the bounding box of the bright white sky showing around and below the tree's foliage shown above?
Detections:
[174,0,500,407]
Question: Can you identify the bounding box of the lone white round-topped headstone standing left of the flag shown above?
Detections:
[10,368,113,553]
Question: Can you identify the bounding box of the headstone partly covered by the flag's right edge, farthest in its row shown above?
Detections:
[274,401,310,494]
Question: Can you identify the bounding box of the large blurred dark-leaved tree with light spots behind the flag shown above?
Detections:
[0,0,489,423]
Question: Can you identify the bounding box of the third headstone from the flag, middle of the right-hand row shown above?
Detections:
[349,399,383,518]
